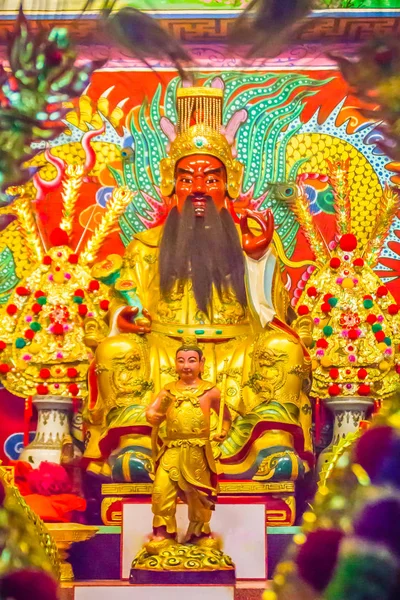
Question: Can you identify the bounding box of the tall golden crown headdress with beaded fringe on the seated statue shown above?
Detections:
[160,87,244,199]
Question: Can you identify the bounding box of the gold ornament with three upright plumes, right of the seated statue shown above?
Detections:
[295,159,400,401]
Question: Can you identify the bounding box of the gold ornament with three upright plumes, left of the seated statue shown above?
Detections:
[0,177,132,398]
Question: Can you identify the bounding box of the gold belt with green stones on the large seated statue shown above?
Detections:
[151,321,251,340]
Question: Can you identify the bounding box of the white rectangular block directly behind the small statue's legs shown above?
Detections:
[122,500,267,580]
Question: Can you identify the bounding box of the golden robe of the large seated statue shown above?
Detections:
[85,226,312,477]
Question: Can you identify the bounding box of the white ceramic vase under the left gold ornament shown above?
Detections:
[19,396,72,467]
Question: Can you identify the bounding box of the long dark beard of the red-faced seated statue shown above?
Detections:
[159,196,247,314]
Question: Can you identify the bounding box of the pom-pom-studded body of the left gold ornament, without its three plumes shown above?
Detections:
[0,241,108,397]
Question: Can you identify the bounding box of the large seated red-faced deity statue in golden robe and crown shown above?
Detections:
[84,88,313,482]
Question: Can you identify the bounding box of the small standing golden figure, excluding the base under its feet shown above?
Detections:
[146,344,231,554]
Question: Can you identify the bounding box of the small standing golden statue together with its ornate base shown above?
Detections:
[131,343,235,583]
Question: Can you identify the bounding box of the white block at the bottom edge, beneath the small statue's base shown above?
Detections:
[74,585,235,600]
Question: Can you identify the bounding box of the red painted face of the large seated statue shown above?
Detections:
[174,154,229,217]
